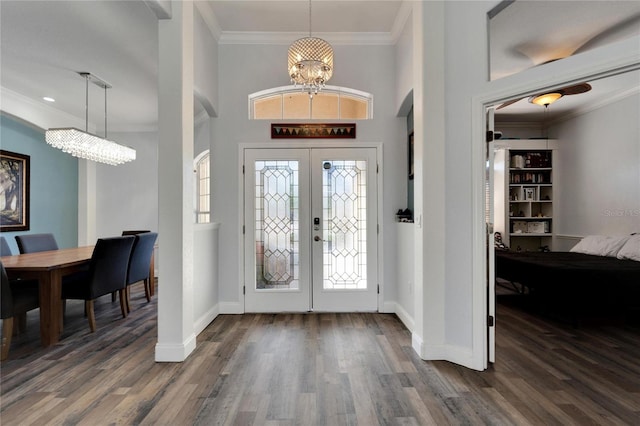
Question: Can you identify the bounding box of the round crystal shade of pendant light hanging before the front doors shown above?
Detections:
[288,37,333,96]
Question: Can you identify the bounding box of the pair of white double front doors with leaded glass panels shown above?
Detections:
[244,148,378,312]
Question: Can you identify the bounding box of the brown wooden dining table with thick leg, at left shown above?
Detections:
[0,246,94,347]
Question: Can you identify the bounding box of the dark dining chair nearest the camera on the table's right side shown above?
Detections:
[62,236,135,333]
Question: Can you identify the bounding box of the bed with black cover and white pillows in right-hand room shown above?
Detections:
[496,235,640,319]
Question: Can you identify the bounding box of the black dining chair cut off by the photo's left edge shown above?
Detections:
[0,262,40,361]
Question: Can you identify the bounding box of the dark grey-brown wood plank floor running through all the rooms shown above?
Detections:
[0,287,640,425]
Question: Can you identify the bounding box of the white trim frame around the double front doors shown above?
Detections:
[236,139,386,313]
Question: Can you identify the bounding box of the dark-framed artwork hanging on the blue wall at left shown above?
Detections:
[0,150,30,232]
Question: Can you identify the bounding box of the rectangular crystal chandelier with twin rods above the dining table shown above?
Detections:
[45,72,136,166]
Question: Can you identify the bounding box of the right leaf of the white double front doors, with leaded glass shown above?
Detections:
[311,148,378,312]
